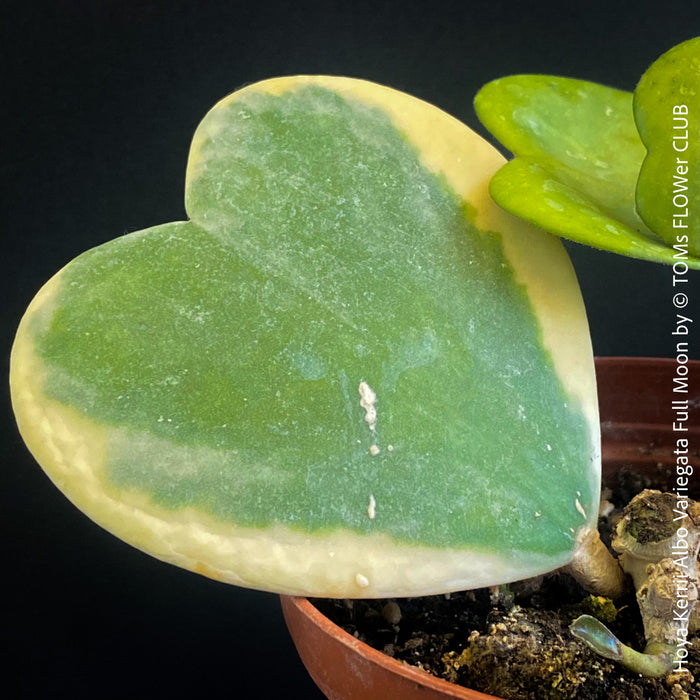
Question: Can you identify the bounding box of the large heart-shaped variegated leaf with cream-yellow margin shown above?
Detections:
[12,77,599,597]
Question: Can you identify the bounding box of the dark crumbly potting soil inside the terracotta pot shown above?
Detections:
[312,470,700,700]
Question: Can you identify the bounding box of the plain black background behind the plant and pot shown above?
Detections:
[0,0,700,698]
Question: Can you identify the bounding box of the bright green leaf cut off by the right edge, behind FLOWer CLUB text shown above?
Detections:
[634,38,700,256]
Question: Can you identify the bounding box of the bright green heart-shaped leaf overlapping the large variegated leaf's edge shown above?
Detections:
[474,75,700,268]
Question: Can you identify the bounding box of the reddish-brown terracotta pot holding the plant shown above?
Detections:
[282,357,700,700]
